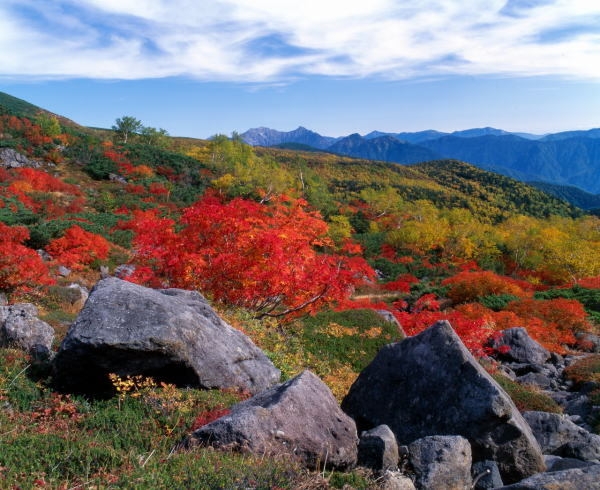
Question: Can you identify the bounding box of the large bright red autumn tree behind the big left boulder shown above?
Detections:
[124,195,373,316]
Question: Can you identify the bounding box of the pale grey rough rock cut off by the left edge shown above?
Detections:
[0,303,54,358]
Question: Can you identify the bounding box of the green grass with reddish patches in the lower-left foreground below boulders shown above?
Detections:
[0,349,372,490]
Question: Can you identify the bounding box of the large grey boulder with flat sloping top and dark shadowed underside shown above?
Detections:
[54,277,280,395]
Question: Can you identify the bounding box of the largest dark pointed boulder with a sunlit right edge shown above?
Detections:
[342,321,544,483]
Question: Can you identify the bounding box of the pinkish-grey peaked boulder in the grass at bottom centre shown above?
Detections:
[183,371,358,469]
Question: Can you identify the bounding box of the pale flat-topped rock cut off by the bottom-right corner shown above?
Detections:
[498,465,600,490]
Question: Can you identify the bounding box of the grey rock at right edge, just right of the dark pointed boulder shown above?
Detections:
[523,411,600,463]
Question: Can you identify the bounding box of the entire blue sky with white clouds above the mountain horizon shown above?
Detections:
[0,0,600,138]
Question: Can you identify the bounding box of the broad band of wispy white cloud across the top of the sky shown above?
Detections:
[0,0,600,83]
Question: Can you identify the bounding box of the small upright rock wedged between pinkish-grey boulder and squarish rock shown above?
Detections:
[358,425,399,471]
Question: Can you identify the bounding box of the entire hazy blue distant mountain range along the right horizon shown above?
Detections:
[241,127,600,194]
